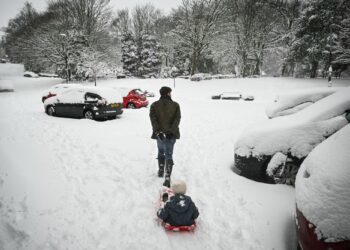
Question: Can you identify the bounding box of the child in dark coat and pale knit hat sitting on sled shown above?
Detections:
[157,181,199,226]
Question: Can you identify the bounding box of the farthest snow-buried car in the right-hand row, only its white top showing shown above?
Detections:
[265,87,340,118]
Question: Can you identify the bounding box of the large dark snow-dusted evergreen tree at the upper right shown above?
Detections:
[290,0,349,78]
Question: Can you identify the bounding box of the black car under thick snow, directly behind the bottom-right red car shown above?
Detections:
[233,87,350,185]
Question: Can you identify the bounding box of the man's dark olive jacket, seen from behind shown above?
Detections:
[149,96,181,139]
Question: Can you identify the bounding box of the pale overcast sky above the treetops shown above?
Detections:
[0,0,181,32]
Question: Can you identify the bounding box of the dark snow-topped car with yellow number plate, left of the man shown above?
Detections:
[44,87,123,120]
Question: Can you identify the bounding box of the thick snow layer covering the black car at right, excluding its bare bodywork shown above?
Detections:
[235,87,350,157]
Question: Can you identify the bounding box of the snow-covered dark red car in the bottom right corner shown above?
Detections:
[295,125,350,250]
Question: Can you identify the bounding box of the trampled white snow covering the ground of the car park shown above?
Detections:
[0,72,350,250]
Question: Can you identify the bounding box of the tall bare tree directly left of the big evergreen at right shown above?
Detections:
[227,0,279,77]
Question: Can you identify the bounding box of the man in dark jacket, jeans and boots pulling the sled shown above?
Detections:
[149,86,181,187]
